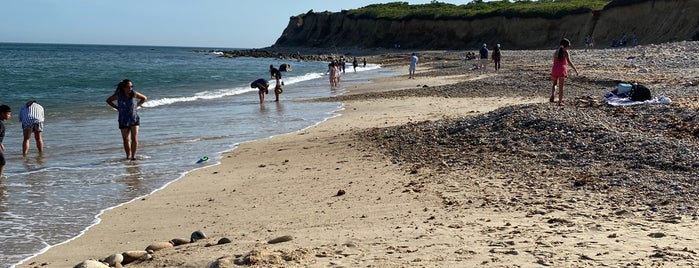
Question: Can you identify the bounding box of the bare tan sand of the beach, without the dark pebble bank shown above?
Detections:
[18,42,699,267]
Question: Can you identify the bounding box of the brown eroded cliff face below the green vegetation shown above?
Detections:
[274,0,699,49]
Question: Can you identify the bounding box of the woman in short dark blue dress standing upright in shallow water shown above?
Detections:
[107,79,148,160]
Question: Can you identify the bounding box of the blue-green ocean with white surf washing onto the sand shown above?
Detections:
[0,43,395,268]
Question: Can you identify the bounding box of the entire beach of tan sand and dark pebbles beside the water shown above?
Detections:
[18,42,699,267]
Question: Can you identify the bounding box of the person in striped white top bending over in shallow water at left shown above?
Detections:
[19,100,44,156]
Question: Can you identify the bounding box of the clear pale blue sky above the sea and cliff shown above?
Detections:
[0,0,471,48]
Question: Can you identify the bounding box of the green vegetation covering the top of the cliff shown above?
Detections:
[342,0,612,20]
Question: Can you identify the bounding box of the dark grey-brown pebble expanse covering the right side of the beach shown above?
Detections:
[358,41,699,216]
